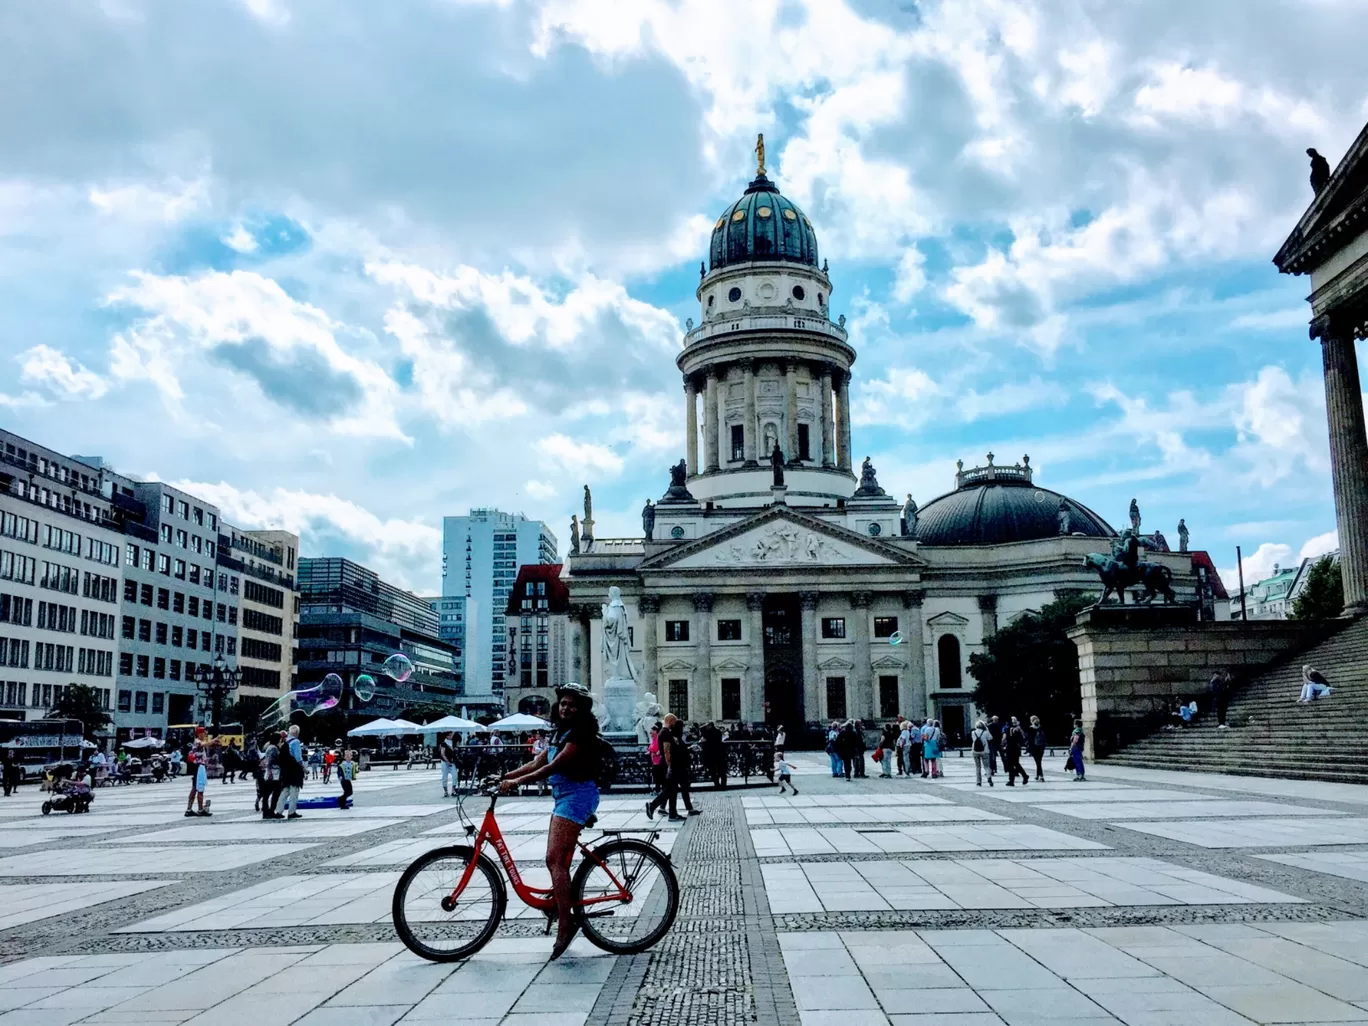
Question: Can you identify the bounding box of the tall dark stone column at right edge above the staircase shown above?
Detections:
[1311,319,1368,614]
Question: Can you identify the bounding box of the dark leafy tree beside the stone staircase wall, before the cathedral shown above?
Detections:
[969,592,1094,740]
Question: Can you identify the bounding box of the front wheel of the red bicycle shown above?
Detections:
[393,844,509,962]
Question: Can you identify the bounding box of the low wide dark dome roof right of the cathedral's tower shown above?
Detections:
[917,480,1116,544]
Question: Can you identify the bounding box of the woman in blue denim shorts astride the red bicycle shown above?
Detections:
[499,681,599,962]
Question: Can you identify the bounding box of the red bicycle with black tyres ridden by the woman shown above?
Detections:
[393,787,680,962]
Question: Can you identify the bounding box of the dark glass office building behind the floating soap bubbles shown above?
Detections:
[295,557,461,717]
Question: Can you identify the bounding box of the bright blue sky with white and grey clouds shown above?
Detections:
[0,0,1368,594]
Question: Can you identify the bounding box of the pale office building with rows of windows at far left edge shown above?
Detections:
[0,431,123,720]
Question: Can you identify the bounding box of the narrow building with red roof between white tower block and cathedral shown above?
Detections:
[503,562,570,717]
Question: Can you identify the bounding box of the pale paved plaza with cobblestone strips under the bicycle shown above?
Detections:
[0,754,1368,1026]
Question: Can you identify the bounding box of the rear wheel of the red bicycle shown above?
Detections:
[570,837,680,955]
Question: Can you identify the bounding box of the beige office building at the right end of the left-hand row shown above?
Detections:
[219,524,300,699]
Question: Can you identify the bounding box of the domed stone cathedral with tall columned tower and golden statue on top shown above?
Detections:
[564,137,1197,739]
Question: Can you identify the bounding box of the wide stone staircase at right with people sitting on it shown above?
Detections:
[1105,618,1368,784]
